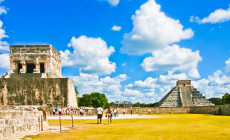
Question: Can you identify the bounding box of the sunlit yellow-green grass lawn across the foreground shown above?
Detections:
[24,114,230,140]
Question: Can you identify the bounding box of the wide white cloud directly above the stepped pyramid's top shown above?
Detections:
[141,45,202,78]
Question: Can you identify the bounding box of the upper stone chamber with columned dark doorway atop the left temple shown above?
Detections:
[10,45,62,78]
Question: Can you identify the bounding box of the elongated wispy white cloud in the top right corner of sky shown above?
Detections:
[190,5,230,24]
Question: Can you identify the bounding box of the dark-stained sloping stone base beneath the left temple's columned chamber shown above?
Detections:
[0,77,77,107]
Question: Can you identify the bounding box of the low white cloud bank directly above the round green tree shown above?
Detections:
[69,73,128,102]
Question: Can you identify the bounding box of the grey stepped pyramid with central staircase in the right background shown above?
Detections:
[156,80,214,107]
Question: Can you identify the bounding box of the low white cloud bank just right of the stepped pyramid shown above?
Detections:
[192,70,230,98]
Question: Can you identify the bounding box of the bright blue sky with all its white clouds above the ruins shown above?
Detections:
[0,0,230,103]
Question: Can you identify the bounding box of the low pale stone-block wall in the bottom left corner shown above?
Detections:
[0,110,42,140]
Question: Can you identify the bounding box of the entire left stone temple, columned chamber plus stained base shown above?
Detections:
[0,45,77,108]
